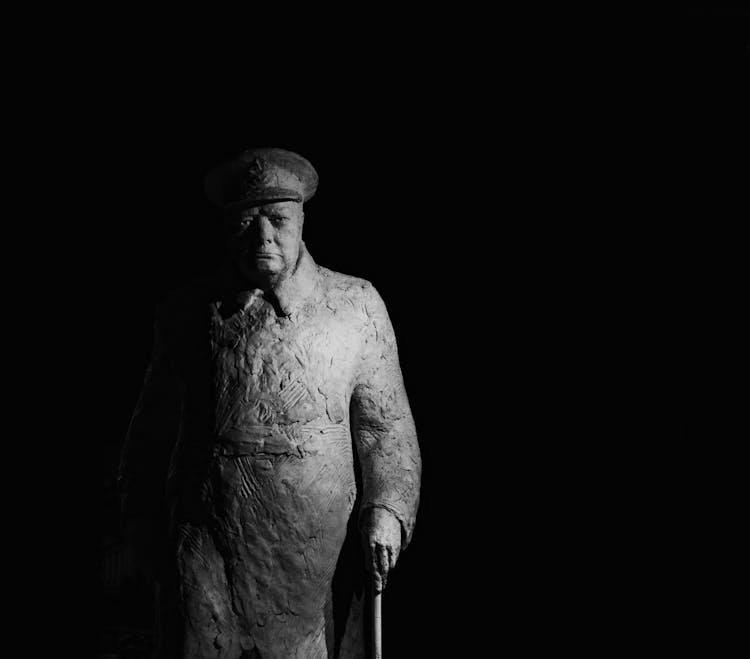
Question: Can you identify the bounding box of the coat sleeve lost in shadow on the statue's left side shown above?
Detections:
[117,306,180,526]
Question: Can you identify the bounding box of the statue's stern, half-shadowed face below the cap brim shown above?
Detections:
[226,201,304,281]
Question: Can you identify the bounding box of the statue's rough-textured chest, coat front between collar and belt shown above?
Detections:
[211,284,365,433]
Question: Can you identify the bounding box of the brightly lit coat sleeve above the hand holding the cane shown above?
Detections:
[351,284,422,548]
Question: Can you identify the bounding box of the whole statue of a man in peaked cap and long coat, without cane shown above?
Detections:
[119,149,421,659]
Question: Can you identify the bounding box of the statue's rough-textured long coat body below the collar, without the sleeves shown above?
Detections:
[166,271,374,656]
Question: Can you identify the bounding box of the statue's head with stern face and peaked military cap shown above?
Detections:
[206,148,318,285]
